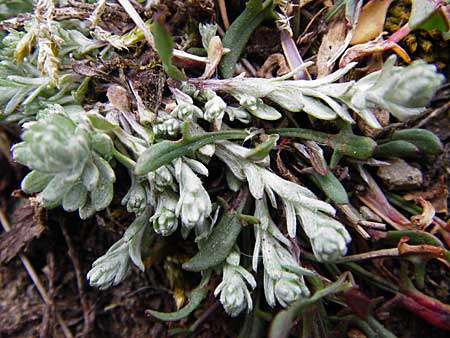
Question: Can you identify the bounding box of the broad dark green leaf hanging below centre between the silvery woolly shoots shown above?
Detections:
[183,212,242,271]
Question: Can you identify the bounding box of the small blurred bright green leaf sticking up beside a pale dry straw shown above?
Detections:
[150,20,186,81]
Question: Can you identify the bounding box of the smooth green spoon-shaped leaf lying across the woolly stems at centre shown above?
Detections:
[134,130,248,176]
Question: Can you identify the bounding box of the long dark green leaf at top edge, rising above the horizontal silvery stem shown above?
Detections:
[219,0,272,79]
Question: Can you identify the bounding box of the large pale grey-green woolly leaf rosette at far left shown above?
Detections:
[12,112,115,219]
